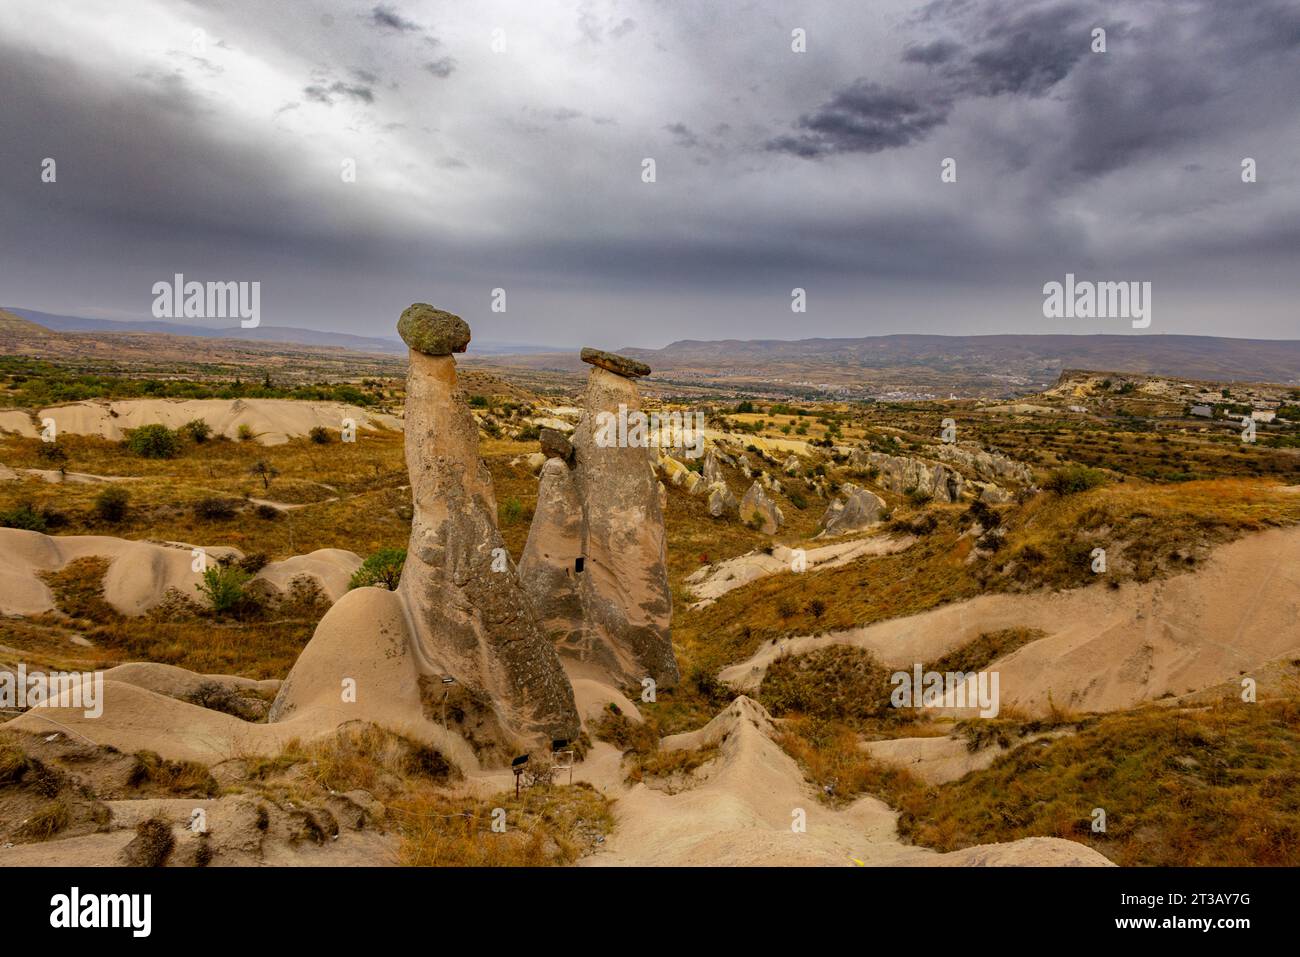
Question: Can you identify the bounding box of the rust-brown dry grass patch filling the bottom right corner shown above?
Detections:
[894,698,1300,867]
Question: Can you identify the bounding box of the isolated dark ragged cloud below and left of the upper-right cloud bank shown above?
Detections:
[767,79,949,159]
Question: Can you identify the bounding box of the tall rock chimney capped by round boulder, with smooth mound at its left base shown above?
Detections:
[272,303,579,763]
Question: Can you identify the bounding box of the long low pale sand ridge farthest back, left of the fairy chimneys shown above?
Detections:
[0,399,402,445]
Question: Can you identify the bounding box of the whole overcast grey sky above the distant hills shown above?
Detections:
[0,0,1300,347]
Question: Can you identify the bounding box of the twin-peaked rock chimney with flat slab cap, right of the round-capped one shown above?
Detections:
[520,350,681,688]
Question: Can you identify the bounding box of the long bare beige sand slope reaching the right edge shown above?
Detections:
[720,528,1300,714]
